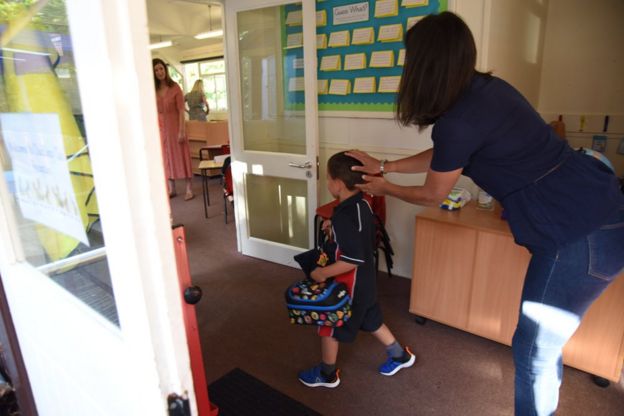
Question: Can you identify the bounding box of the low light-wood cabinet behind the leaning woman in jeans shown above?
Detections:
[410,203,624,381]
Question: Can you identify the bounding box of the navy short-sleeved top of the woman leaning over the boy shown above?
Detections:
[431,75,624,250]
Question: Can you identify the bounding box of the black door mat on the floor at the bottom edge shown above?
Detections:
[208,368,321,416]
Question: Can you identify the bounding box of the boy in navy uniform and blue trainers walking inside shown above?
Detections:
[299,152,416,388]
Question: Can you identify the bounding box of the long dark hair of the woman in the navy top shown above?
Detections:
[396,12,489,127]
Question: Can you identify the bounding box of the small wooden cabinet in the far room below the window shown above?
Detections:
[186,120,230,175]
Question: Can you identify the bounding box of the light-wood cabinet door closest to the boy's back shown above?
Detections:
[410,218,477,329]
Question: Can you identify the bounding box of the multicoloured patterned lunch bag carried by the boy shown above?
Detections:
[286,279,351,327]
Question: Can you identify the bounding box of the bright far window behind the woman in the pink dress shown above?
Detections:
[184,59,227,111]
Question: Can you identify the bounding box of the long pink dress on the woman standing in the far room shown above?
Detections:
[156,83,193,179]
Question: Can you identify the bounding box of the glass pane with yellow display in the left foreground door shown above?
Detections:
[0,0,119,324]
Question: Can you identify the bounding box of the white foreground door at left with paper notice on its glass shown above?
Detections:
[0,0,196,416]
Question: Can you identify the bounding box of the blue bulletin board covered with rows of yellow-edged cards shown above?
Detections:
[282,0,448,112]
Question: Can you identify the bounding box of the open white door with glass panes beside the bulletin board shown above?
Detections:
[225,0,318,265]
